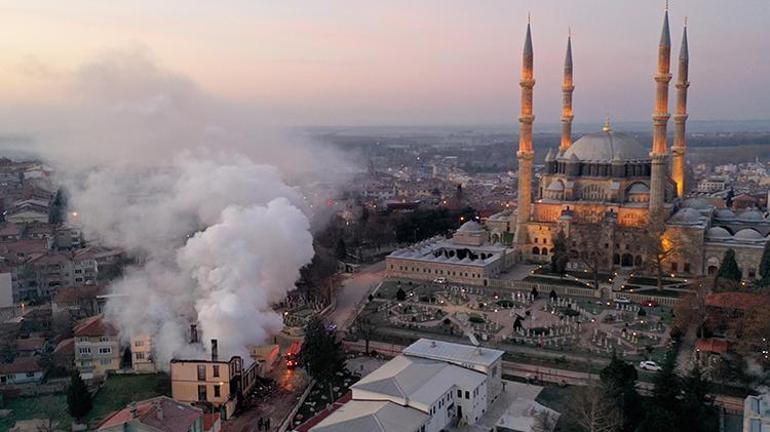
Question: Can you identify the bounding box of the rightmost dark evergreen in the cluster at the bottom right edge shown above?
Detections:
[679,364,719,432]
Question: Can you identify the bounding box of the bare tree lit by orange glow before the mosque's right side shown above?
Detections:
[639,210,693,290]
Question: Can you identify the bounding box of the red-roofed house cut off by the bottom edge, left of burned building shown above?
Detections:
[97,396,221,432]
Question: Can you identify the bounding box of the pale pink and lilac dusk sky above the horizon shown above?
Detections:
[0,0,770,125]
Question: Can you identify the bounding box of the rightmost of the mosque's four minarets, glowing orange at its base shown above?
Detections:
[671,19,690,198]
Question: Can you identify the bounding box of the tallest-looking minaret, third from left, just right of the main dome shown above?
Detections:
[650,6,671,211]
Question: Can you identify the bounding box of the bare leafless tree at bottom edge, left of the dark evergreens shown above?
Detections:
[567,384,623,432]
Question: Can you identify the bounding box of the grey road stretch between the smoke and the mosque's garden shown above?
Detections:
[329,261,385,330]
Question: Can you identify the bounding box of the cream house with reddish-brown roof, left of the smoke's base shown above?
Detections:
[74,315,120,380]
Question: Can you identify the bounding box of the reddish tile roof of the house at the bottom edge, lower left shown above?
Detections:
[97,396,203,432]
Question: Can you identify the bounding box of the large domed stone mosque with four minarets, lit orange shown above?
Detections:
[386,10,770,285]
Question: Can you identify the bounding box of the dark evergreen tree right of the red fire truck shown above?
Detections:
[300,317,345,403]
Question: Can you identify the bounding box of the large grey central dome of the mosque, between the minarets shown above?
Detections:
[563,130,650,162]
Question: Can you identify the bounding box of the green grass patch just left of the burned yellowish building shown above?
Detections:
[86,373,171,422]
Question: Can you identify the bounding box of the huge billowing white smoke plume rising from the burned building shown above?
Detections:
[6,49,356,368]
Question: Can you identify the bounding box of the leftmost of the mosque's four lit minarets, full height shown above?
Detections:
[515,19,535,245]
